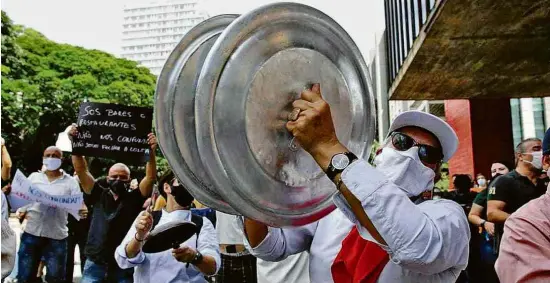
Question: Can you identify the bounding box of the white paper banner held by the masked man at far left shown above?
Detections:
[10,170,84,220]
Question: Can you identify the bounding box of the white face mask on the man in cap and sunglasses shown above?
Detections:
[374,146,435,197]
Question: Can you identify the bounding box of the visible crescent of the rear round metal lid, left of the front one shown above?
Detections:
[155,15,238,214]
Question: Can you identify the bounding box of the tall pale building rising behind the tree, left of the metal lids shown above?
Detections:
[121,0,207,75]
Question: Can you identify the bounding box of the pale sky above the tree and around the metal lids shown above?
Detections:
[1,0,384,60]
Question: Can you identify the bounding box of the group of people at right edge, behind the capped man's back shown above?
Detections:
[442,134,550,283]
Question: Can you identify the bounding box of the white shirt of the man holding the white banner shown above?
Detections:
[20,172,81,240]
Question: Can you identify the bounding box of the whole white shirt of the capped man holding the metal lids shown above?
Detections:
[245,160,470,283]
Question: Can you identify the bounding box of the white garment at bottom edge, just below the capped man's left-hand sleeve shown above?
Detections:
[256,252,311,283]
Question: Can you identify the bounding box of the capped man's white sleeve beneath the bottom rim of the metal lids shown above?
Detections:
[239,217,318,261]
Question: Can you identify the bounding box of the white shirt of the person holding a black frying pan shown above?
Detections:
[115,210,221,283]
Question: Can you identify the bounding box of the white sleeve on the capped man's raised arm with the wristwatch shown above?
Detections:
[334,160,470,274]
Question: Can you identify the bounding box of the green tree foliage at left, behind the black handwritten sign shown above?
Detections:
[2,11,162,175]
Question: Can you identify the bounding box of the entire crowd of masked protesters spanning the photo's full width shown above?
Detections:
[1,111,550,283]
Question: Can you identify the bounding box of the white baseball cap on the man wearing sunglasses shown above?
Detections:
[389,111,458,162]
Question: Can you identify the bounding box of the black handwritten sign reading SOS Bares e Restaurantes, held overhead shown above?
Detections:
[72,102,153,163]
